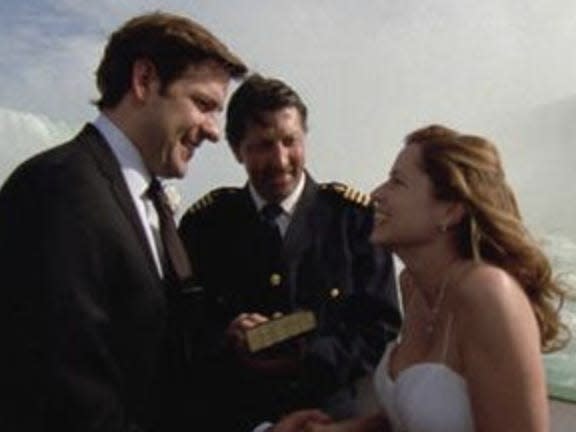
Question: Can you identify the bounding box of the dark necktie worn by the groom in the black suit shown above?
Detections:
[148,179,192,282]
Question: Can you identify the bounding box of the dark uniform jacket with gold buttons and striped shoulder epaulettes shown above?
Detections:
[180,176,399,431]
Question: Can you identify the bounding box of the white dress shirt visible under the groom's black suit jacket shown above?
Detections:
[92,114,163,276]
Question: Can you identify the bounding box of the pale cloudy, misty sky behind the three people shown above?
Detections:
[0,0,576,251]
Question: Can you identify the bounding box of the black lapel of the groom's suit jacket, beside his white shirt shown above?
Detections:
[78,124,156,276]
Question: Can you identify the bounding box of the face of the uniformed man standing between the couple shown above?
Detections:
[236,107,306,202]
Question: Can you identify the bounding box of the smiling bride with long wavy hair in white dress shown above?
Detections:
[306,126,567,432]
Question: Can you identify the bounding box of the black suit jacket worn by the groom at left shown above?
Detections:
[0,125,173,432]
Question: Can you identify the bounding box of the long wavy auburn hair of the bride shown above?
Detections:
[405,125,570,352]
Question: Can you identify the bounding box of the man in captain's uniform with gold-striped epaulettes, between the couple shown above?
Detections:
[179,75,399,431]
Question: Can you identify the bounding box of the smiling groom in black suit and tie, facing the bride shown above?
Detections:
[0,12,246,432]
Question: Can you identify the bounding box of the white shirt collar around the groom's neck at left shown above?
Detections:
[92,113,152,198]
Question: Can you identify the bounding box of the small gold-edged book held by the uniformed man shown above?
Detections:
[246,311,316,352]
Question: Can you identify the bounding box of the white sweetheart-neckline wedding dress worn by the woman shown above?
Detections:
[374,343,474,432]
